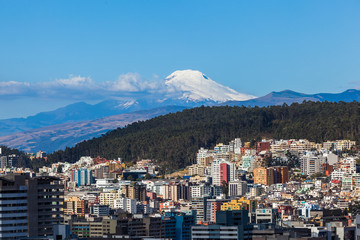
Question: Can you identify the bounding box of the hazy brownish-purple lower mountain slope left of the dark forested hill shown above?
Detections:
[0,106,185,152]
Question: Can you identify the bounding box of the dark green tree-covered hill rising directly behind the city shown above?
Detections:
[49,102,360,169]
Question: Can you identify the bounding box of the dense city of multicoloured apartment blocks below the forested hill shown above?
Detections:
[0,138,360,239]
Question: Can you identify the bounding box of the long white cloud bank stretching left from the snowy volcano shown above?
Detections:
[0,73,163,100]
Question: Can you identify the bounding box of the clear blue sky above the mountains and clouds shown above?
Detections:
[0,0,360,118]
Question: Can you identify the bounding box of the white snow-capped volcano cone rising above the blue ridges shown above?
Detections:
[165,70,255,102]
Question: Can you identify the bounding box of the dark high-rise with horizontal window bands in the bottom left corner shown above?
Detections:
[0,174,64,239]
